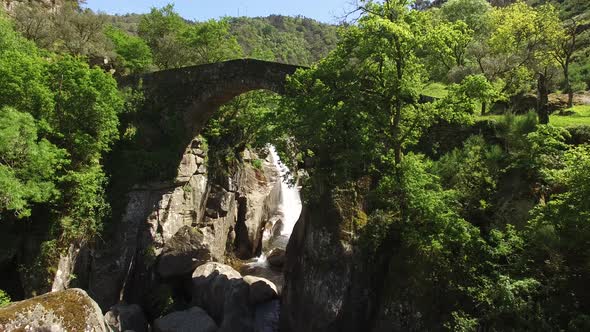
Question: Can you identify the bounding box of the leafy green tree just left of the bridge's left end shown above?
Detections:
[46,56,123,165]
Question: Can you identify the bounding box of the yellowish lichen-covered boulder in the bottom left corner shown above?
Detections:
[0,288,108,332]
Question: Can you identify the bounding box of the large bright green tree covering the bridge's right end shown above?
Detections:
[278,1,476,181]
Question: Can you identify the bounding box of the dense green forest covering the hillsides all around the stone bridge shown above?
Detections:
[0,0,590,331]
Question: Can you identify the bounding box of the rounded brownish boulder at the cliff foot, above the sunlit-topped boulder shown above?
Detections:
[157,226,211,278]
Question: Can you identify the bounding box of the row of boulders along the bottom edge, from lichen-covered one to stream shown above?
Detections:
[0,262,279,332]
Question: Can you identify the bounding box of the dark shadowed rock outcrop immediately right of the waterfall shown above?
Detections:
[281,189,371,332]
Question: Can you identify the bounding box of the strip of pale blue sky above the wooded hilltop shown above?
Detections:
[86,0,352,23]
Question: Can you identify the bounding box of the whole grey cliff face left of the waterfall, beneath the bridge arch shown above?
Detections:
[82,138,280,312]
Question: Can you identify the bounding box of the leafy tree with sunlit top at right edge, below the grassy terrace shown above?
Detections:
[526,145,590,331]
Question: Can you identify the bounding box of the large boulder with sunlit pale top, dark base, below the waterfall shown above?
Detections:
[192,262,253,331]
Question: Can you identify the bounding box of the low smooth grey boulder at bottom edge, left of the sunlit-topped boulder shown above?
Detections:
[154,307,217,332]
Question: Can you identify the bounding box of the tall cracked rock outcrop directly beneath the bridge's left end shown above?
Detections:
[86,138,210,310]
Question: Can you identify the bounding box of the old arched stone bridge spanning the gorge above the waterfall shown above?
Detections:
[119,59,304,134]
